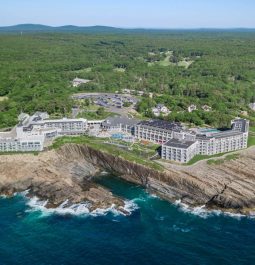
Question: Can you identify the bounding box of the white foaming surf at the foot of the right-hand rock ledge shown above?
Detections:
[174,200,248,220]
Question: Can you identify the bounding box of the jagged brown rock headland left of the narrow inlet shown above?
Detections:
[0,151,124,210]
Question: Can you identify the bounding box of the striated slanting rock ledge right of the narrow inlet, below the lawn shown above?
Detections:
[58,144,255,213]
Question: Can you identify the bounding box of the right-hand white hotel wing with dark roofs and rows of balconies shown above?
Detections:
[135,119,249,163]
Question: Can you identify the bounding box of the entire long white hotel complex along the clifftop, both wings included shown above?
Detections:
[0,109,249,163]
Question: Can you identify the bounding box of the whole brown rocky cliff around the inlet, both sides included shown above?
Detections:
[0,144,255,213]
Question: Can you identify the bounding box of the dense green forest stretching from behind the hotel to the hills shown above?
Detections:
[0,31,255,128]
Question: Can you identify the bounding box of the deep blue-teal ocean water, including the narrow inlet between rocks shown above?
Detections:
[0,174,255,265]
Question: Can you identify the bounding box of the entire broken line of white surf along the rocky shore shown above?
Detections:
[0,191,255,220]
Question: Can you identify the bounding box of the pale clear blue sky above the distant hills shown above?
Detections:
[0,0,255,29]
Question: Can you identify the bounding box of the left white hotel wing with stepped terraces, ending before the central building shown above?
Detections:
[0,112,103,152]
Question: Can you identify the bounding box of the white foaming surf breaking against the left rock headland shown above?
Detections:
[26,197,138,217]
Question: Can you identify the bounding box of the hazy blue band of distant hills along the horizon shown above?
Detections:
[0,24,255,33]
